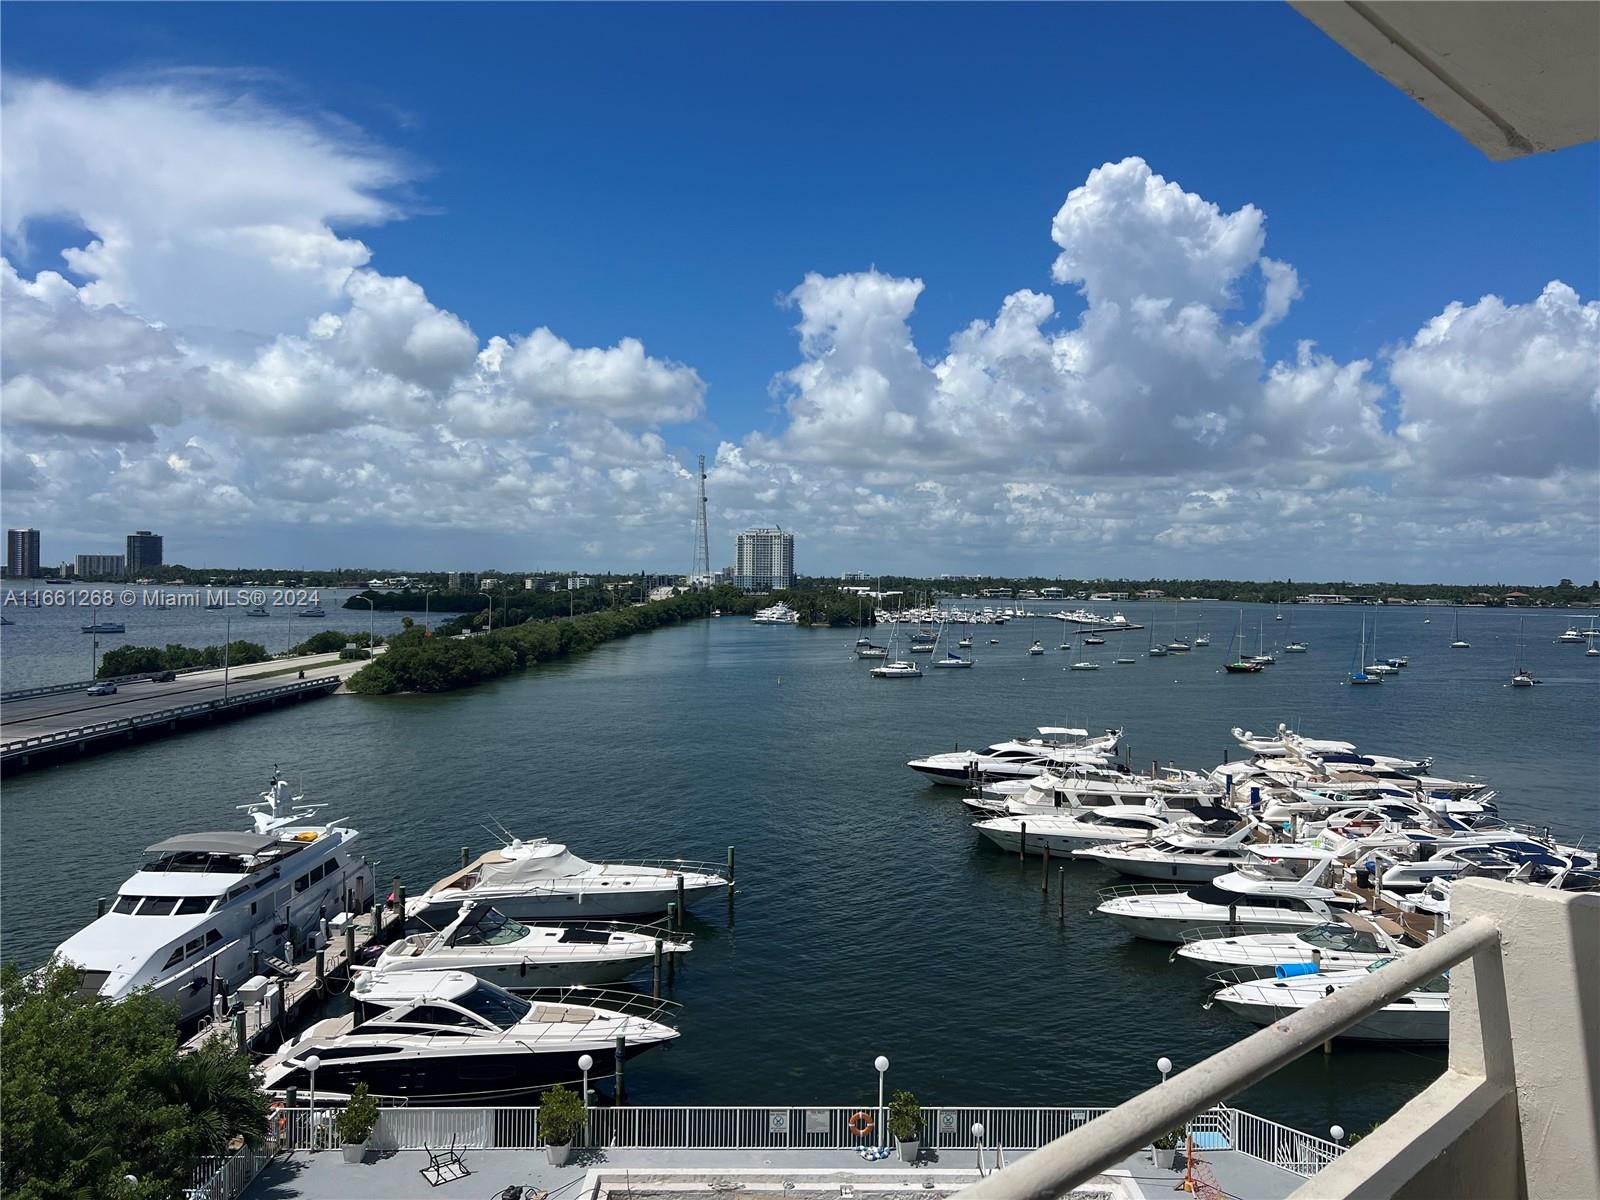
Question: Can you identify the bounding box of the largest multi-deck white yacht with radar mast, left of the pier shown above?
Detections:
[47,774,373,1021]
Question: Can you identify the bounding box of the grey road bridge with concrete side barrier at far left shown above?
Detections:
[0,646,382,771]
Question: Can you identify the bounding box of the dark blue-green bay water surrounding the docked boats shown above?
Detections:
[0,602,1600,1131]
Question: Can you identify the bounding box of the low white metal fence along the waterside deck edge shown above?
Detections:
[268,1104,1344,1177]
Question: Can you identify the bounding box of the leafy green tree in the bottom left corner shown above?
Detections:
[0,963,267,1200]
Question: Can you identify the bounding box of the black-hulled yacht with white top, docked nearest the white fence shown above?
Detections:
[261,971,678,1104]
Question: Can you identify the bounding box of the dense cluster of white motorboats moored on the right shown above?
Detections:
[909,726,1600,1043]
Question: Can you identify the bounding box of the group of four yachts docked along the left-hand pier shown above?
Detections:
[43,776,731,1104]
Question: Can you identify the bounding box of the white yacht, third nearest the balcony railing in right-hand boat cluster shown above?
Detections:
[1096,843,1362,942]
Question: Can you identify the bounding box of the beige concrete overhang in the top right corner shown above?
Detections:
[1291,0,1600,160]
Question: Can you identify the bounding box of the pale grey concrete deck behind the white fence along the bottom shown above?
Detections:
[245,1150,1304,1200]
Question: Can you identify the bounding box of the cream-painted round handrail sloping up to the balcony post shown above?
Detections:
[965,917,1499,1200]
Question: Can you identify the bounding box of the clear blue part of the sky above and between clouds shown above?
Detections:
[3,5,1600,574]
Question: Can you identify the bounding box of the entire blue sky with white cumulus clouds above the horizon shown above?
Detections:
[0,3,1600,582]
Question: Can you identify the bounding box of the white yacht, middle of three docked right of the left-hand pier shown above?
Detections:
[382,904,690,992]
